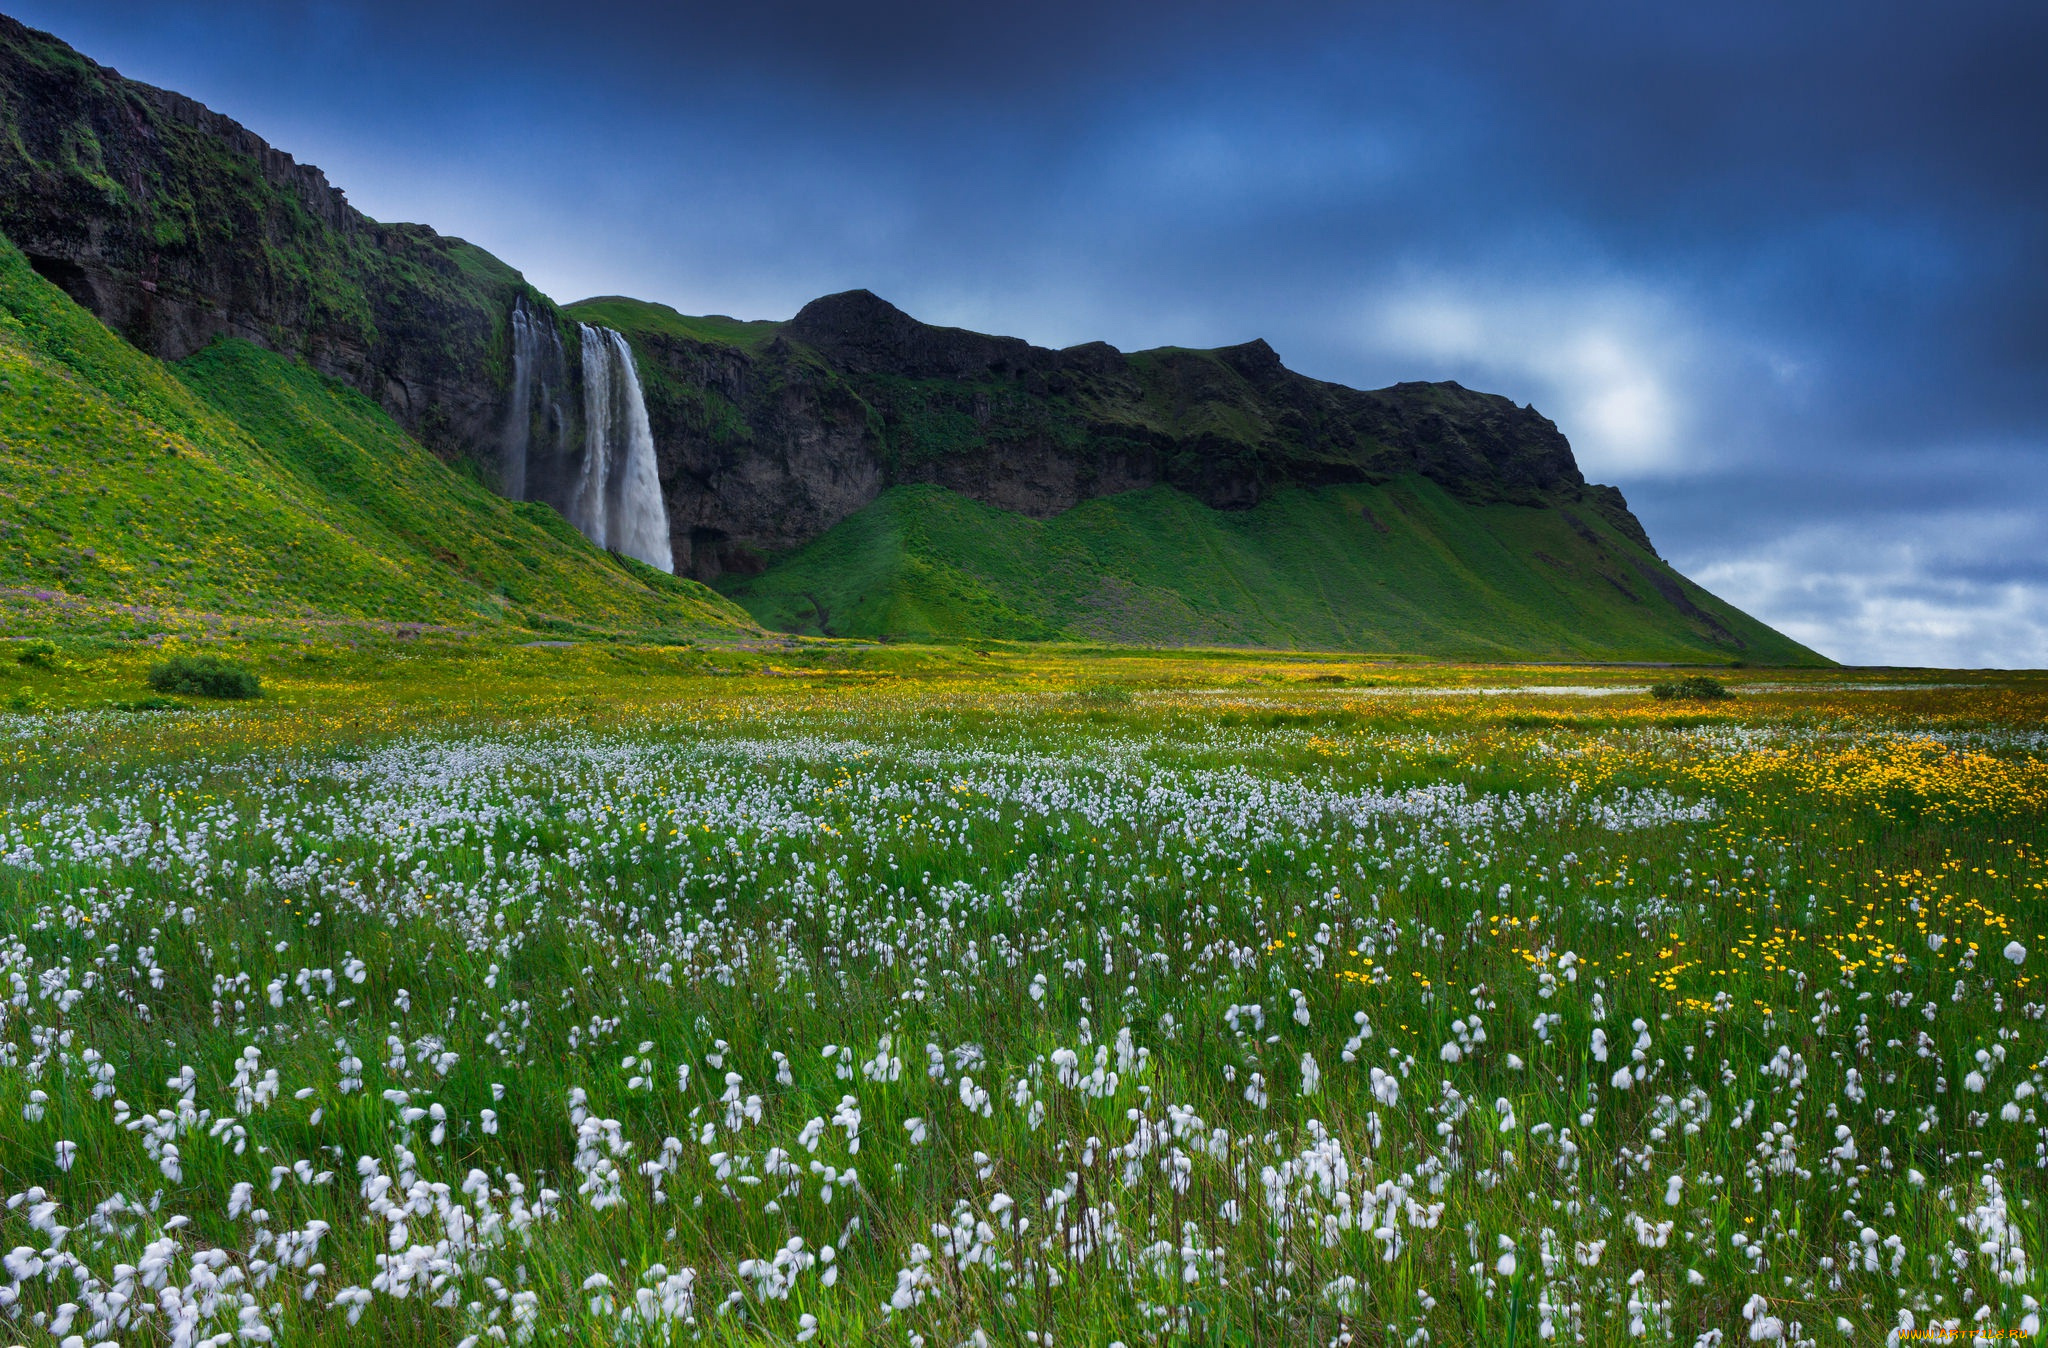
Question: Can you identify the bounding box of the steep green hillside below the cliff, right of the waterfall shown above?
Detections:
[719,475,1823,664]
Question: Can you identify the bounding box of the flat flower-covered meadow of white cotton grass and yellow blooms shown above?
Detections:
[0,635,2048,1348]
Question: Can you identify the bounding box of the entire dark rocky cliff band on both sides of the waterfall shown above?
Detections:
[0,16,1649,594]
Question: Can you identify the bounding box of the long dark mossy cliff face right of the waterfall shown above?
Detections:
[569,291,1649,578]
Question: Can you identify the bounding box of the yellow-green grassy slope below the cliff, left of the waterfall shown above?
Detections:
[0,240,750,631]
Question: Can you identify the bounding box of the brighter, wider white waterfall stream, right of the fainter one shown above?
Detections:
[567,324,676,572]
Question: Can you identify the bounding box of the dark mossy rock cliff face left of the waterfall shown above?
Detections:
[0,16,551,463]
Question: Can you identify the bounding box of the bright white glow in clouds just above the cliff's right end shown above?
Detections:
[1366,289,1688,479]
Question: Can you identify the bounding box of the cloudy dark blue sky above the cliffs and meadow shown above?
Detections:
[8,0,2048,666]
